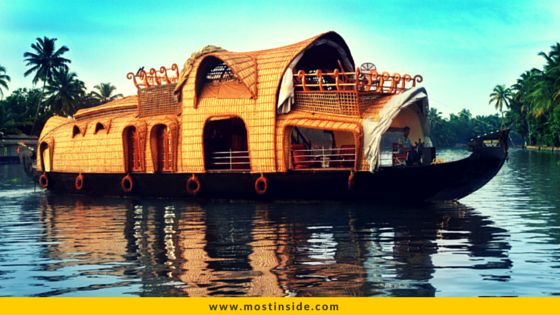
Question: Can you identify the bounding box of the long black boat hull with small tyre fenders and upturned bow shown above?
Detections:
[41,148,507,202]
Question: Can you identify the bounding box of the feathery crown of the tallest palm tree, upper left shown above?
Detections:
[23,36,71,86]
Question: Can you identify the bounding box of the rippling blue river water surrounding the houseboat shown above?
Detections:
[0,151,560,296]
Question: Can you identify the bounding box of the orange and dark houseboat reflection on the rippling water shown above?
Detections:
[36,195,512,296]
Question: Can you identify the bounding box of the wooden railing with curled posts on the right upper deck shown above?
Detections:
[294,68,423,94]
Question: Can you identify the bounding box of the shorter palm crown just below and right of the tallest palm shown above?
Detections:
[46,70,85,116]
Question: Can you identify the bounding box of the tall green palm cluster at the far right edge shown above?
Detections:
[490,43,560,146]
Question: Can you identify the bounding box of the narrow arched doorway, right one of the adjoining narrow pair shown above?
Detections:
[150,124,173,173]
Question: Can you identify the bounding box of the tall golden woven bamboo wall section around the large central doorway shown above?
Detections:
[179,37,317,173]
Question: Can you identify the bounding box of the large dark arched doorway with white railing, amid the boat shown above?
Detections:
[204,117,251,171]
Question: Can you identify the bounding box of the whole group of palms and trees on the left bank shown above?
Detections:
[0,37,122,135]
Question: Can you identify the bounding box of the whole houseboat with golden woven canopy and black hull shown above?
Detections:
[32,32,507,201]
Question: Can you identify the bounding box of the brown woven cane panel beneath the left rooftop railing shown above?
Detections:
[138,84,180,117]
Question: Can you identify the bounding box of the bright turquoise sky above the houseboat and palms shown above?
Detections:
[0,0,560,115]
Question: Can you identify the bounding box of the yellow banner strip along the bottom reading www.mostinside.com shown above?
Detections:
[0,298,560,315]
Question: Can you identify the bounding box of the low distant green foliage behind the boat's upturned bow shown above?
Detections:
[428,108,501,147]
